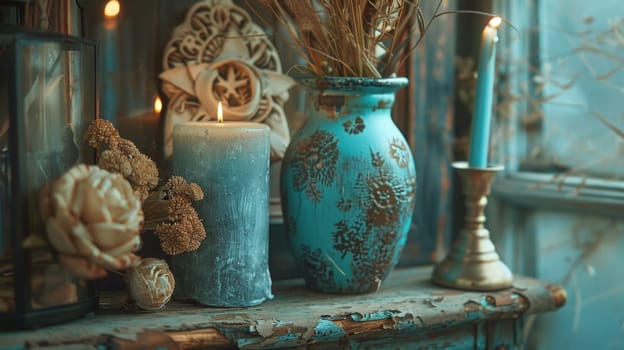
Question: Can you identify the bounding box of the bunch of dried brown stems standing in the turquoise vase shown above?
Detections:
[262,0,441,78]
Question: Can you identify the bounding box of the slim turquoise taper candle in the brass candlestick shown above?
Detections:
[468,17,502,168]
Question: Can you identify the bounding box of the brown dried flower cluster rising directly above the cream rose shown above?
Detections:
[85,119,158,201]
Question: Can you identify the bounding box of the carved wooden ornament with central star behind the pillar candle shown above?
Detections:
[159,0,294,160]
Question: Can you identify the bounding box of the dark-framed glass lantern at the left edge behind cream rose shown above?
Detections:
[0,28,97,329]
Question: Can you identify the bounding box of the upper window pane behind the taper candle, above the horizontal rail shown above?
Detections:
[494,0,624,179]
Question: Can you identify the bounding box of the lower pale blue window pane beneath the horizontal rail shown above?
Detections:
[510,211,624,349]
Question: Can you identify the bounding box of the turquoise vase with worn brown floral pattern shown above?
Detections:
[280,77,416,293]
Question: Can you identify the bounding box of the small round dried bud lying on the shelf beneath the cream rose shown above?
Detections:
[126,258,175,310]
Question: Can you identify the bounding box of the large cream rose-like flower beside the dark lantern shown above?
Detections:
[44,164,143,278]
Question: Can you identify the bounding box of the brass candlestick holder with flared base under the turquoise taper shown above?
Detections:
[433,162,512,291]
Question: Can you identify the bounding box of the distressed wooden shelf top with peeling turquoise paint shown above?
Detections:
[0,267,565,349]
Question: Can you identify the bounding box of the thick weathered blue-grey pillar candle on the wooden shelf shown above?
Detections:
[171,122,273,307]
